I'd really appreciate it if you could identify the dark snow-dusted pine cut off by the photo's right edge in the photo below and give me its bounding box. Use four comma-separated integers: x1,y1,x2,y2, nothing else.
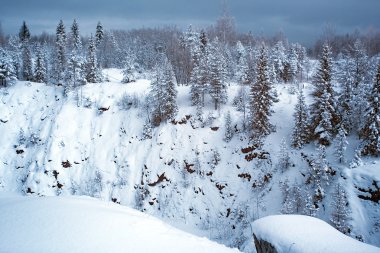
360,63,380,156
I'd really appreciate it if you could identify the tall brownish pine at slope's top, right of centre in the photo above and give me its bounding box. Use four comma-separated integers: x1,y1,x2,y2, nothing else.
249,45,274,143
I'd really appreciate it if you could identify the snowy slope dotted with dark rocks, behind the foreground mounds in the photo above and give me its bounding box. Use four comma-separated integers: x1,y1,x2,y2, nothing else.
0,69,380,252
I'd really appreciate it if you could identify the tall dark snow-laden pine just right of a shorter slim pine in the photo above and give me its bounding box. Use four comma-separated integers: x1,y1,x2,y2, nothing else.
310,44,339,145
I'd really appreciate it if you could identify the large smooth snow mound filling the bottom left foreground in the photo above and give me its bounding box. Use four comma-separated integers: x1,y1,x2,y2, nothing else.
0,194,238,253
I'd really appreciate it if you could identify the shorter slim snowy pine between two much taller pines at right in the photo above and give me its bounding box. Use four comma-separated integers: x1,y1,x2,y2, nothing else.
292,89,309,148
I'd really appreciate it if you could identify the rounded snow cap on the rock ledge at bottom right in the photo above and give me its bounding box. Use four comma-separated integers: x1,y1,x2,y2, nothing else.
252,215,380,253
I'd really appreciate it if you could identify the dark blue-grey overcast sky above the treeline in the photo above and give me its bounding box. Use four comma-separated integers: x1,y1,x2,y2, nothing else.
0,0,380,44
